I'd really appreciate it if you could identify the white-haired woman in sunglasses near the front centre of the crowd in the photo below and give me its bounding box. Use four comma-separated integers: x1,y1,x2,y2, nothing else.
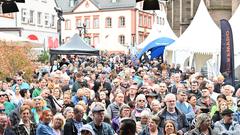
132,94,150,121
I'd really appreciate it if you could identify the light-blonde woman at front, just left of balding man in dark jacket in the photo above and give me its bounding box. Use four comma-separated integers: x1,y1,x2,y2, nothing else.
52,113,65,135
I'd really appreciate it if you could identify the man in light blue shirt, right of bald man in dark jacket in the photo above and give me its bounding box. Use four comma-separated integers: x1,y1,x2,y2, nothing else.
176,89,195,122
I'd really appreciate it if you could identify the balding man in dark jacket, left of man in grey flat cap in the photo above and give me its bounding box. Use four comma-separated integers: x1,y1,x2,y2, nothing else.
63,105,87,135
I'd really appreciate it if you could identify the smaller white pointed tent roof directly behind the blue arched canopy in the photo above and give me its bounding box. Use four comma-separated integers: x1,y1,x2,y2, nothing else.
137,10,177,49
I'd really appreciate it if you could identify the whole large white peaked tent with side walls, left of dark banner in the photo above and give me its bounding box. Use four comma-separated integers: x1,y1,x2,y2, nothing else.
165,0,221,74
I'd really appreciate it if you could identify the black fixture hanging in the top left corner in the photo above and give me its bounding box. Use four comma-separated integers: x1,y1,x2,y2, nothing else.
2,1,19,13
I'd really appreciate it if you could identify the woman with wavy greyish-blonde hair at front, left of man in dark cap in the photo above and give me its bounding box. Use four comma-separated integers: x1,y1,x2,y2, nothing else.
187,113,213,135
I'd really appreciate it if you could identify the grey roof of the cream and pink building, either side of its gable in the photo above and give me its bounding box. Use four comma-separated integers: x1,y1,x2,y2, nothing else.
56,0,136,12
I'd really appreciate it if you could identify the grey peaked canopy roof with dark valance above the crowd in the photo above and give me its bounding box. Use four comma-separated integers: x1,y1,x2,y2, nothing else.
50,34,99,55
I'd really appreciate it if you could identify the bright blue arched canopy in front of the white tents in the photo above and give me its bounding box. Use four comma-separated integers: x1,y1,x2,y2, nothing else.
138,37,175,59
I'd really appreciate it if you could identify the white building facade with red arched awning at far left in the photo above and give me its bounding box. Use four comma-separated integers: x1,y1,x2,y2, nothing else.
0,0,59,49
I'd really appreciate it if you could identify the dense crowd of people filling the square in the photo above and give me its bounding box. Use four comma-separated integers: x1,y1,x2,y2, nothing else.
0,55,240,135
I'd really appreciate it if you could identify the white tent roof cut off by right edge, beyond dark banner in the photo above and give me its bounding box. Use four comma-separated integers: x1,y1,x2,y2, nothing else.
229,5,240,53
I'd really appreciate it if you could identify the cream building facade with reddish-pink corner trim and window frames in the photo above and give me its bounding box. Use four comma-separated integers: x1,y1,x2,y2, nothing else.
57,0,164,46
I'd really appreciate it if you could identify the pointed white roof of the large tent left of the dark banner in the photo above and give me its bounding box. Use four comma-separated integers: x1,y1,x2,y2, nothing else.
166,0,221,54
